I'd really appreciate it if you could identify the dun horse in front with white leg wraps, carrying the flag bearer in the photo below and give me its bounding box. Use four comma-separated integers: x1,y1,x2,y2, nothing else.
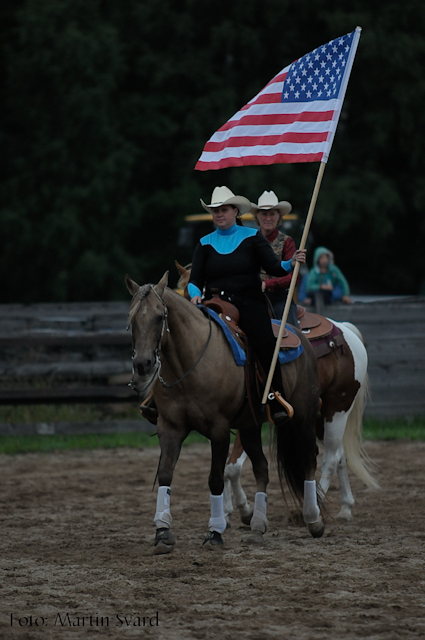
126,272,324,553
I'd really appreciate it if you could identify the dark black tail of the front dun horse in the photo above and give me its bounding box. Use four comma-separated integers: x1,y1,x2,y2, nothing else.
273,417,317,507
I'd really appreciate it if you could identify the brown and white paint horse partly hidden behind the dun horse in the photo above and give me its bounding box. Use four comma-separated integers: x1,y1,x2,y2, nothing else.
176,262,379,524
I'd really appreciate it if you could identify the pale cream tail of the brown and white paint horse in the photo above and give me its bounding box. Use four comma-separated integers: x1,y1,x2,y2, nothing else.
342,374,380,489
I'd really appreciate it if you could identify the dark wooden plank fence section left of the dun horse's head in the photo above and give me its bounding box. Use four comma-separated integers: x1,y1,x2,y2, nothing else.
0,302,132,404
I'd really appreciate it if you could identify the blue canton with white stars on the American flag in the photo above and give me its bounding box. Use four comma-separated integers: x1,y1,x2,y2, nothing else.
281,31,354,102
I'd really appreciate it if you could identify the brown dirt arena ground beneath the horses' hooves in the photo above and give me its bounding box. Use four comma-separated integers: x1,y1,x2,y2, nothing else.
0,442,425,640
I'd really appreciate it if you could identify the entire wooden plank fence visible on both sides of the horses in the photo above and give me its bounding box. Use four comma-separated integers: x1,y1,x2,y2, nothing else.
0,297,425,434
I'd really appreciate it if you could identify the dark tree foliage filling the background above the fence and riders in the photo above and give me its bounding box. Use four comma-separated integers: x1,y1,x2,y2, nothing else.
0,0,425,302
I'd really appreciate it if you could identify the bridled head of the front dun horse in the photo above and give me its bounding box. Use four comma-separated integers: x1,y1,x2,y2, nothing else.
125,271,168,396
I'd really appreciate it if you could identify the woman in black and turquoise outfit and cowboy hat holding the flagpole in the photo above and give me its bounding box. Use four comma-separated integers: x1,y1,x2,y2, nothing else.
188,187,305,426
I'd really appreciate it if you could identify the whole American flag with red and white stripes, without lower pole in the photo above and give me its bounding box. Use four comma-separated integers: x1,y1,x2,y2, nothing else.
195,27,361,171
